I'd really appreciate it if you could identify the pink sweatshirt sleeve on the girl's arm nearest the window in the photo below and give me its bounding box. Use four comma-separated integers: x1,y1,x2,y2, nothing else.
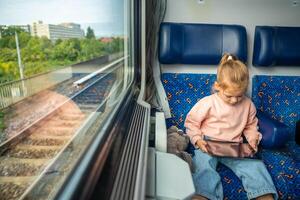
184,98,210,146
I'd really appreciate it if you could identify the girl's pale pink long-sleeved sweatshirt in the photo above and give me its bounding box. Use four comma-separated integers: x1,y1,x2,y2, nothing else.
184,93,262,150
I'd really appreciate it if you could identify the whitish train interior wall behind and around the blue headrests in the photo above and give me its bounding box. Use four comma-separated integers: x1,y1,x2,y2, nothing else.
162,0,300,96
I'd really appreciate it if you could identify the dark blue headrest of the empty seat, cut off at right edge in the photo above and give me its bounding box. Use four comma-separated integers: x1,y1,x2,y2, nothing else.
252,26,300,66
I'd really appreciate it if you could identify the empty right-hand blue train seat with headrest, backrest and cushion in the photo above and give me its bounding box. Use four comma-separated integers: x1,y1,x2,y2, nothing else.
252,26,300,199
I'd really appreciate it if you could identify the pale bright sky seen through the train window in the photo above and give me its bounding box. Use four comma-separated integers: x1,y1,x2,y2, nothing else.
0,0,124,36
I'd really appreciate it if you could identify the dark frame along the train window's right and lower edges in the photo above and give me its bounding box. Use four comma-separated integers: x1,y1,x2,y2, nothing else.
54,0,141,200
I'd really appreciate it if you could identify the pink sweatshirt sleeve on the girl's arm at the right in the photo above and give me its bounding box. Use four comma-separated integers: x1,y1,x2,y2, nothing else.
243,102,262,151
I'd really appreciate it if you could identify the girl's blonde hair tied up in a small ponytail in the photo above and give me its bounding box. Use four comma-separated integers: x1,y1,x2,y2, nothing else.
216,53,249,92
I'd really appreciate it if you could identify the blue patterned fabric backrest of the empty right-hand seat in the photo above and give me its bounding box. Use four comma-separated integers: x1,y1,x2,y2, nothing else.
252,76,300,131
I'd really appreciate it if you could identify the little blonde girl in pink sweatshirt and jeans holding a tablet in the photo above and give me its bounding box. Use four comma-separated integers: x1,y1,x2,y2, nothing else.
185,54,278,200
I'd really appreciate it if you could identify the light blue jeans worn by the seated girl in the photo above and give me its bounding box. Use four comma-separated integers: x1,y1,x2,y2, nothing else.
193,149,278,200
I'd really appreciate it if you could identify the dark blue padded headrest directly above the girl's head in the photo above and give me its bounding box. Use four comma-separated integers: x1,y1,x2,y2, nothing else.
159,23,247,65
